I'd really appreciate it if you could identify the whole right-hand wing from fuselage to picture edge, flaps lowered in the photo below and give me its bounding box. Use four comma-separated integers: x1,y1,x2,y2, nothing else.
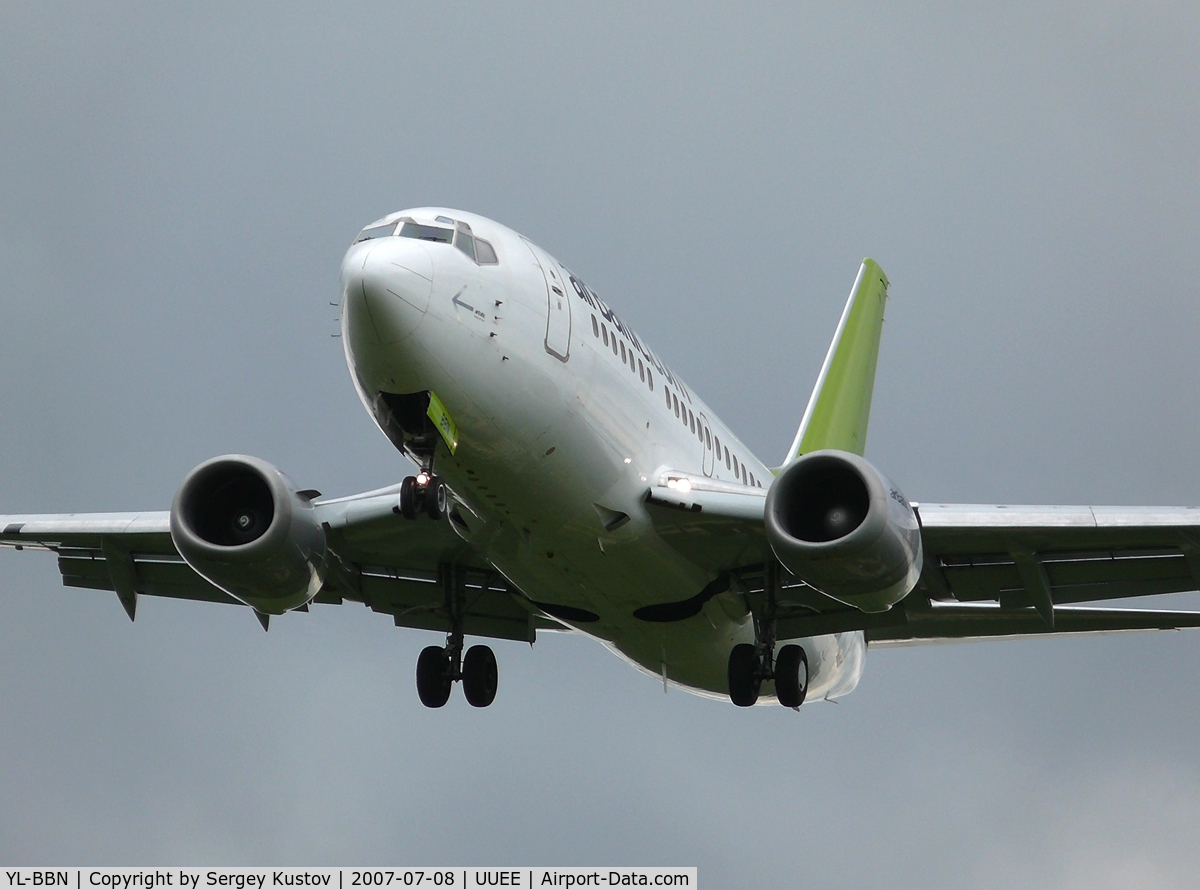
646,484,1200,645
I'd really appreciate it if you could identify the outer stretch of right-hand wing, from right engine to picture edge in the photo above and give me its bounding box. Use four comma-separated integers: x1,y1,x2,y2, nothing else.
883,504,1200,643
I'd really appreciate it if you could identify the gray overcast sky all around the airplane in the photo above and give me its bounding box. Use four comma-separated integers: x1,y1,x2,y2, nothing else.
0,2,1200,888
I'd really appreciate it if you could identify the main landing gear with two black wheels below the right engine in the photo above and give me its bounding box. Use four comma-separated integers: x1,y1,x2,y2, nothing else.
728,561,809,708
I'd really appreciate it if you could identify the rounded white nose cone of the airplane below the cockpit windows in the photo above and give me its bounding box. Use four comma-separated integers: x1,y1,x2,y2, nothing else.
342,237,433,345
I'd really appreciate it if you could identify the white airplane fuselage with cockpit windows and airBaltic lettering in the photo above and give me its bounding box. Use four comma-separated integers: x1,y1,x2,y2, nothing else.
341,208,865,700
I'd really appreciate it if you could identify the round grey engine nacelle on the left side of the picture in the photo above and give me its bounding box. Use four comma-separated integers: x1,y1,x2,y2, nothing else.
170,455,325,615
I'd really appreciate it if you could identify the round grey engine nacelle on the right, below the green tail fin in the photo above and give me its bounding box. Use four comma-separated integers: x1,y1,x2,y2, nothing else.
764,450,922,612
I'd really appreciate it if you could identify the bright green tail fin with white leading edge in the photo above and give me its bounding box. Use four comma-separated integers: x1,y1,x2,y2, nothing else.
784,258,888,464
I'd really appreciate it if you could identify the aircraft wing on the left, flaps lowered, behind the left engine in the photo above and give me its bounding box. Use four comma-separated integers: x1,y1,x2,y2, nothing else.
0,487,544,642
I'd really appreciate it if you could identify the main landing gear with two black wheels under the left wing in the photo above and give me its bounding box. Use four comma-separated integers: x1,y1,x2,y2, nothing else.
415,563,499,708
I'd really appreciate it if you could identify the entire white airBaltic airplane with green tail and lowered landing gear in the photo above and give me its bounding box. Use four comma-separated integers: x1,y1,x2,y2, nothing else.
0,208,1200,708
